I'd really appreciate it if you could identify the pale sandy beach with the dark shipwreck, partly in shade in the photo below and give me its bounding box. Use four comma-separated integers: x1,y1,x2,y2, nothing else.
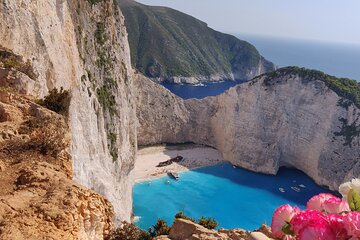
131,144,224,182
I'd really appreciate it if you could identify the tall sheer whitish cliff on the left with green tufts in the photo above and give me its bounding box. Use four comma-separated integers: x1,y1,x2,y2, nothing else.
0,0,137,220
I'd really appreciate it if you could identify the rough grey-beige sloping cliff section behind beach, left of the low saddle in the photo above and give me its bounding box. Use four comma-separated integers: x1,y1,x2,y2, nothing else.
135,74,191,145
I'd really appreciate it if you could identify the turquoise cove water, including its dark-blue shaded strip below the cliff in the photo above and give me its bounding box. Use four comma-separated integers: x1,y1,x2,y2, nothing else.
133,163,334,230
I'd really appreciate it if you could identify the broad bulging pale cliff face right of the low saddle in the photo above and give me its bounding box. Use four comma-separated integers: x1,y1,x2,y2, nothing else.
211,76,360,189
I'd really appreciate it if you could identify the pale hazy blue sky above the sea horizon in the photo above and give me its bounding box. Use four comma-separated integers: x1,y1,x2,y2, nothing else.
138,0,360,44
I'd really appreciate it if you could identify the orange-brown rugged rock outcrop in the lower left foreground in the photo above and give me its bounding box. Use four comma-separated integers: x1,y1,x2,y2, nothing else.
0,91,113,240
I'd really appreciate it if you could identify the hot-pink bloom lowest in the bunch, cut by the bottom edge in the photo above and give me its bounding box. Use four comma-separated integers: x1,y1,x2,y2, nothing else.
297,222,338,240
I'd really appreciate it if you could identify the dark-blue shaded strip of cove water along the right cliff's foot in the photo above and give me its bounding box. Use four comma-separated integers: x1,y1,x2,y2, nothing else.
192,163,336,206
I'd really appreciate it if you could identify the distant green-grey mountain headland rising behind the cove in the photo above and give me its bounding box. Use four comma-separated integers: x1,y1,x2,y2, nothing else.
118,0,274,83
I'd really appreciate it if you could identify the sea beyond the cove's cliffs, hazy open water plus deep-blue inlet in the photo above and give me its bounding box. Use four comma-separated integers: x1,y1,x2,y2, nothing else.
164,34,360,99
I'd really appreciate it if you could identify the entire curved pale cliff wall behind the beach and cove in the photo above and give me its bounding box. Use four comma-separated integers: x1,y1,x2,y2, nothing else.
137,68,360,189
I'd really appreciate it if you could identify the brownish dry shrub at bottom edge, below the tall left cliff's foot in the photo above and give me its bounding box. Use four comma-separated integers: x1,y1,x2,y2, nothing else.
105,222,152,240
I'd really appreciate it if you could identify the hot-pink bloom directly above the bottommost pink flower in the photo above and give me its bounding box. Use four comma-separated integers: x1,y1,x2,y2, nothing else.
290,210,328,235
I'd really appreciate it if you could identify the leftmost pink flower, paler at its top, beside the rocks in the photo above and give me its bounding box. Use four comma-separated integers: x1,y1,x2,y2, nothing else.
271,204,300,238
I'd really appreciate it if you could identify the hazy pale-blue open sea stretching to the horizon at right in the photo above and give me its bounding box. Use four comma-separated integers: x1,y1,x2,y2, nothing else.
236,34,360,81
